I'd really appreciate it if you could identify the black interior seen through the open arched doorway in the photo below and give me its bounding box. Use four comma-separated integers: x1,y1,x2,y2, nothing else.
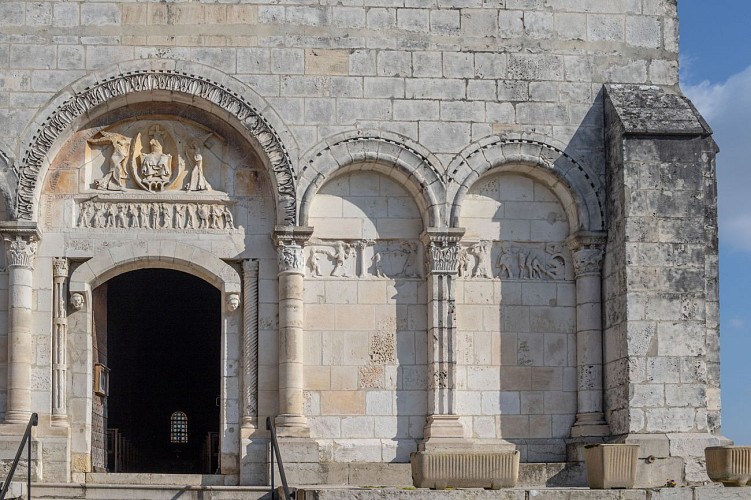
107,269,221,473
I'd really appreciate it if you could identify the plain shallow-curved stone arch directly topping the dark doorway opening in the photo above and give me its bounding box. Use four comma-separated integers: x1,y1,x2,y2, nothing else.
69,241,242,294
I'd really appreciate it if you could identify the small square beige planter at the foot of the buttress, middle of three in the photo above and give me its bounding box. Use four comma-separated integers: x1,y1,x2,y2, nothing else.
584,444,639,489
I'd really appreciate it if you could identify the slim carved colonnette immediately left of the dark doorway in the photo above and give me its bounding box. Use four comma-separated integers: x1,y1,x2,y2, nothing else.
51,257,68,426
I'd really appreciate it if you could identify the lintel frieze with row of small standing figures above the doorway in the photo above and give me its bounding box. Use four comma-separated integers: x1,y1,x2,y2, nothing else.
77,200,235,231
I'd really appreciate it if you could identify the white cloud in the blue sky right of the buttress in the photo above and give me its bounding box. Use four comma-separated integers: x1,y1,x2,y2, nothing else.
683,66,751,252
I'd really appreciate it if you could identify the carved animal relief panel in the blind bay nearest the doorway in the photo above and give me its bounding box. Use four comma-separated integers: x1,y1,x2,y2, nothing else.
305,240,424,278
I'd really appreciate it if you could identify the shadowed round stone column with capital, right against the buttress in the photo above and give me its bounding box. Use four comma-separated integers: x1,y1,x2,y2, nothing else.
567,233,610,437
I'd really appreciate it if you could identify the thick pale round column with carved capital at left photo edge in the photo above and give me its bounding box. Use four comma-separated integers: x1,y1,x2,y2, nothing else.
0,223,39,424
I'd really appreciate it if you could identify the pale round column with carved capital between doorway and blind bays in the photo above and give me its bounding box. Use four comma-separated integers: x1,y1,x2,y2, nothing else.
274,226,313,437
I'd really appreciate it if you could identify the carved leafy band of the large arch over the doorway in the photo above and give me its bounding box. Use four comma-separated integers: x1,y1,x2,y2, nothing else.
16,64,296,225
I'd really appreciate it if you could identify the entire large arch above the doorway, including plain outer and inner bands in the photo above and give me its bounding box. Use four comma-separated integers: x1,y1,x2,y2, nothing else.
14,60,297,225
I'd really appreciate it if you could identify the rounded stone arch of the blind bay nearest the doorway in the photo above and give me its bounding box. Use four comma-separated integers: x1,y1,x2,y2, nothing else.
297,131,446,227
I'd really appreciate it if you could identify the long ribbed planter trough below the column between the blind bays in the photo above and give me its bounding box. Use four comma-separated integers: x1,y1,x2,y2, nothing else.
410,451,519,489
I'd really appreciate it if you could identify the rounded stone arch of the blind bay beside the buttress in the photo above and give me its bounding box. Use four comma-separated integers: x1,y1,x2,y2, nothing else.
448,136,605,233
